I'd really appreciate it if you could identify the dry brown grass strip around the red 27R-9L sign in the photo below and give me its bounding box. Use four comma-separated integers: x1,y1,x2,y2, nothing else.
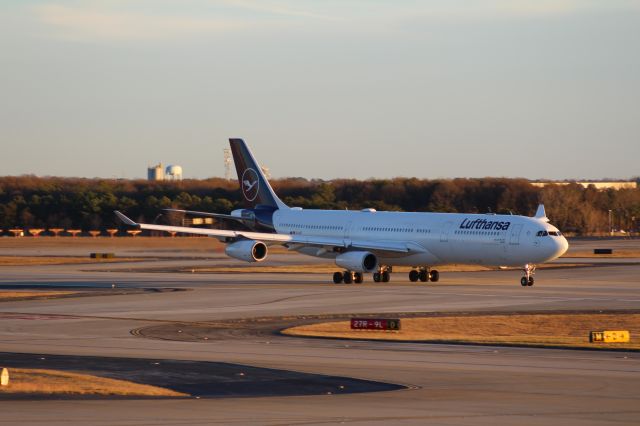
283,314,640,349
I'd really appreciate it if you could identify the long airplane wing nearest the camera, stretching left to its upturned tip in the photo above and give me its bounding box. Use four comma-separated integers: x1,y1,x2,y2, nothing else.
115,211,426,255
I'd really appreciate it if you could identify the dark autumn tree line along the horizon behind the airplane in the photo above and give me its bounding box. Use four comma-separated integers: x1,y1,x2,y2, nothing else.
0,176,640,235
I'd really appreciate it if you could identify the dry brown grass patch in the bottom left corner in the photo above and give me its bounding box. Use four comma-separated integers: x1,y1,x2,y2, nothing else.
0,368,188,396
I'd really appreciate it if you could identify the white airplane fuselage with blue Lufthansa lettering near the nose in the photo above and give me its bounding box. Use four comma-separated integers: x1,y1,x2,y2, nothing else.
273,208,568,266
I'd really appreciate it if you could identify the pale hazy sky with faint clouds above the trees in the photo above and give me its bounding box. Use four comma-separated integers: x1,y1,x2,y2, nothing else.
0,0,640,179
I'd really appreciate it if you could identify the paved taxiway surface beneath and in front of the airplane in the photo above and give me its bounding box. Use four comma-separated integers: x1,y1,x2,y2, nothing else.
0,238,640,425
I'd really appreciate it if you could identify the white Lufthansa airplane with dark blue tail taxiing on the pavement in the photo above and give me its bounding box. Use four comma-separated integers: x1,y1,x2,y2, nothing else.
115,139,569,287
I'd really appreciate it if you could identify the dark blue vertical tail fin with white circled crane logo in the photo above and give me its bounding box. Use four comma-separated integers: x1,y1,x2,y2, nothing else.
229,139,287,210
